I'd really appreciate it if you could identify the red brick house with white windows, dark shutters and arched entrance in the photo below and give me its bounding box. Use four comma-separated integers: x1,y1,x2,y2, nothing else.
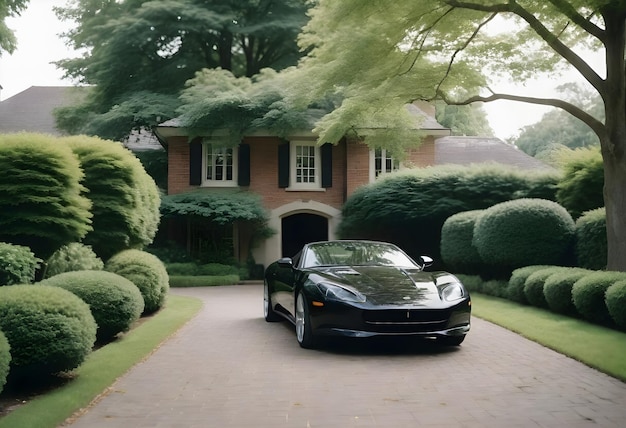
154,101,450,266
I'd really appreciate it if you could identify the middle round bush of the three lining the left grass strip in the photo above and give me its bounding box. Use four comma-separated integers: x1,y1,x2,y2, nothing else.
39,270,144,340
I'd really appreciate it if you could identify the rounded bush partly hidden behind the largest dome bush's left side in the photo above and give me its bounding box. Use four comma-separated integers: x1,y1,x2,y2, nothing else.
440,210,483,274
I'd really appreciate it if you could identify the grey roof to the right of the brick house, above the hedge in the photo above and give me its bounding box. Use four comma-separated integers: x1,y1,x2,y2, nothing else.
435,136,553,171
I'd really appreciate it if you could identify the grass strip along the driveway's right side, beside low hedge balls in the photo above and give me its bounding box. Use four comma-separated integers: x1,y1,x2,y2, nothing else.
472,293,626,381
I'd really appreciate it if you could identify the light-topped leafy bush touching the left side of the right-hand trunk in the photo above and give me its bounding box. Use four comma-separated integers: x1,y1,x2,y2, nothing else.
556,146,604,218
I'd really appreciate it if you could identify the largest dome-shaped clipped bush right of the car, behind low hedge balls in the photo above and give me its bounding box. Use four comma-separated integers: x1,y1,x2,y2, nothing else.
473,199,574,272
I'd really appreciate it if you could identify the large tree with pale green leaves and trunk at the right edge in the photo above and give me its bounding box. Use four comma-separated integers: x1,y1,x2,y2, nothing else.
290,0,626,271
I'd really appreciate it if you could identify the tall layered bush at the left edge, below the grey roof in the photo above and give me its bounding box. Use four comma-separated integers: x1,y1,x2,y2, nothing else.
0,133,91,260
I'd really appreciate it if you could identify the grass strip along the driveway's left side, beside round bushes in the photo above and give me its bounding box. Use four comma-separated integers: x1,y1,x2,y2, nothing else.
0,294,202,428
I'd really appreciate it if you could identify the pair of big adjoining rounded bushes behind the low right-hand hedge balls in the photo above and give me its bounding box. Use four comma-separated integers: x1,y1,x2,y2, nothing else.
441,198,575,279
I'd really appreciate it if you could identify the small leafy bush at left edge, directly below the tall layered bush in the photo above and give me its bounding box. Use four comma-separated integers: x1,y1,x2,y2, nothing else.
0,242,41,285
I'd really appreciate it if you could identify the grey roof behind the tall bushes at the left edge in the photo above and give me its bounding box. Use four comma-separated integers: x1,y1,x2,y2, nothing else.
0,86,85,135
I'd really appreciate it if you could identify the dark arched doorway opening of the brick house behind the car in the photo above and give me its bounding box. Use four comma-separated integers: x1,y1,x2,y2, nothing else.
281,213,328,257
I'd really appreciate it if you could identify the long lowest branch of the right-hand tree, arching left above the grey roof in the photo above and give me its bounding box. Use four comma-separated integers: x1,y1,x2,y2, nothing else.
438,92,606,139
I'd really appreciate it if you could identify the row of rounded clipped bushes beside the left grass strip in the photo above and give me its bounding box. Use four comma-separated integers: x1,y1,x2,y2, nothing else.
0,246,169,387
